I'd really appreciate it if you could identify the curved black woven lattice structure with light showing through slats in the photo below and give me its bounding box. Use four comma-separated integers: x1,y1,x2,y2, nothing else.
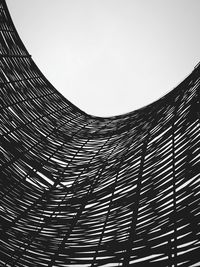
0,0,200,267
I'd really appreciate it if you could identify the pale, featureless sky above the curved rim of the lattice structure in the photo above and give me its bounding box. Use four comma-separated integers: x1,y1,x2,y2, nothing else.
7,0,200,116
